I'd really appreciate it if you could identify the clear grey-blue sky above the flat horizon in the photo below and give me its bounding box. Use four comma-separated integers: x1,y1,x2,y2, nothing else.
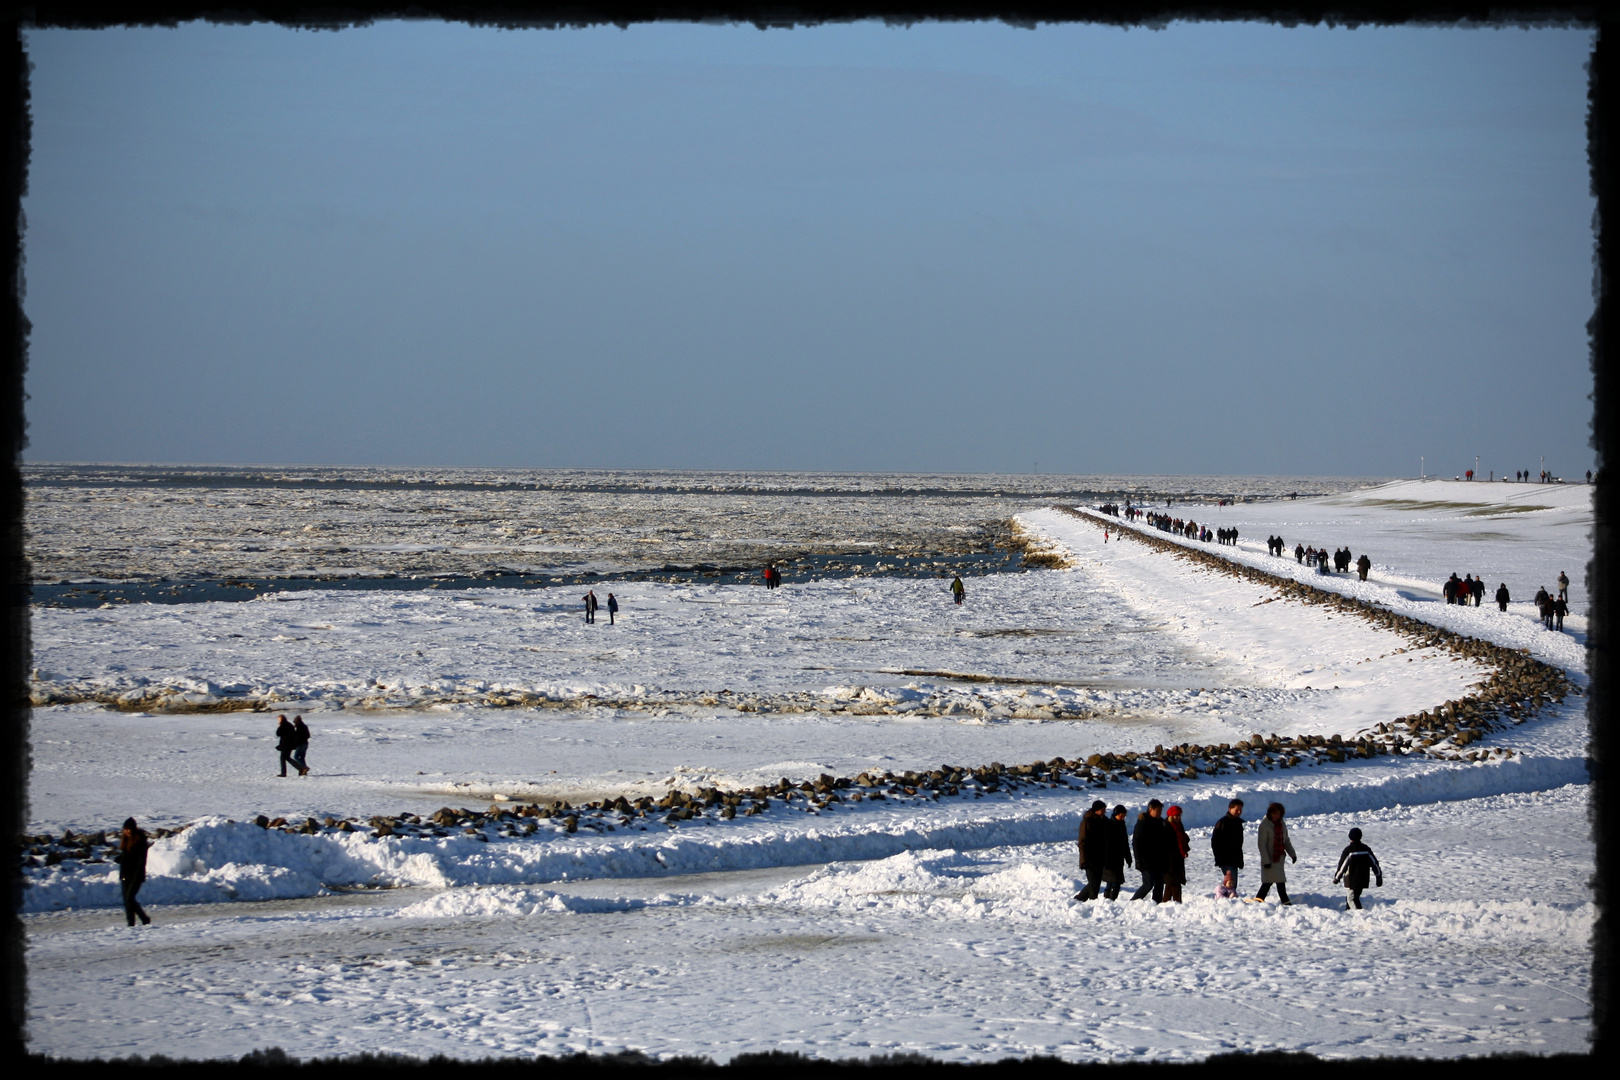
24,23,1596,476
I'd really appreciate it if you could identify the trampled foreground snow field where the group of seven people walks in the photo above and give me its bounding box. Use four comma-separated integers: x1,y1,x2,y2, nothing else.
29,785,1592,1061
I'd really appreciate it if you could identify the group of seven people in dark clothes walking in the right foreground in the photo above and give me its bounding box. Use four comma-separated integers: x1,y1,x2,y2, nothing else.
1074,798,1383,910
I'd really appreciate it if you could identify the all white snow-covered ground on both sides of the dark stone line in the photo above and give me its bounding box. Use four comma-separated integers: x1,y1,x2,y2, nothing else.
24,484,1592,1061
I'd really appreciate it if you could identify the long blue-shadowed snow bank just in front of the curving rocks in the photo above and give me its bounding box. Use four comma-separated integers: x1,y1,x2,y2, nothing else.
24,706,1586,912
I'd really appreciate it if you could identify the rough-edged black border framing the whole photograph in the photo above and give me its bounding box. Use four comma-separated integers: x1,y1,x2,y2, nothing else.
0,0,1620,1075
